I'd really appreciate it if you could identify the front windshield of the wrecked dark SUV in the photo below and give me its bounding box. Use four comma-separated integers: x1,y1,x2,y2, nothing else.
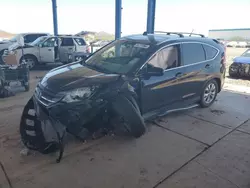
85,40,150,74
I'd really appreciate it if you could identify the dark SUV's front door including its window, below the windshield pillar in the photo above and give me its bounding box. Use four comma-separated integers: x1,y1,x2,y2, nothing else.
141,45,185,113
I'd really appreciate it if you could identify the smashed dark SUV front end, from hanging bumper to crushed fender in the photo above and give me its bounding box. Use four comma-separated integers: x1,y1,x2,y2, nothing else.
20,78,145,162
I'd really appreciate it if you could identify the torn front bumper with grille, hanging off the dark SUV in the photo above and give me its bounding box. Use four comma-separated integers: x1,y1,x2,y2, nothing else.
20,84,106,162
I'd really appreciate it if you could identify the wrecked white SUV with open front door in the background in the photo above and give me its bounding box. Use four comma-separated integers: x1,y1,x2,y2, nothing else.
3,35,90,69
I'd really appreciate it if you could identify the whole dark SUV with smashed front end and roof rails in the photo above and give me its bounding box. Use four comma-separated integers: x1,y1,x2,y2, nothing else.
20,32,225,162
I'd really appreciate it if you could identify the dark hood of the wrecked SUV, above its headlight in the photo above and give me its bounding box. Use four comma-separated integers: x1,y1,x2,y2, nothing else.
41,62,119,93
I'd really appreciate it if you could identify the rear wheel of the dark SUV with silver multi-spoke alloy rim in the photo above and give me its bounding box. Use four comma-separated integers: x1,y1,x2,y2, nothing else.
200,79,218,108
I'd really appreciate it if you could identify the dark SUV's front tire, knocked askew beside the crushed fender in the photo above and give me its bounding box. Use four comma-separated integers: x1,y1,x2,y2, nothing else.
112,95,146,138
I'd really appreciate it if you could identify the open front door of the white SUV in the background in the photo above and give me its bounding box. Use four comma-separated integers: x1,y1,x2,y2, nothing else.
39,37,56,63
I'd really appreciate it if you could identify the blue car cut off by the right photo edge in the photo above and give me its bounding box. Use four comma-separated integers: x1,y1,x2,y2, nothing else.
229,49,250,77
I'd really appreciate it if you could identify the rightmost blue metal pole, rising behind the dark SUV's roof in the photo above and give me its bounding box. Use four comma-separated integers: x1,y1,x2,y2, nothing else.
147,0,156,33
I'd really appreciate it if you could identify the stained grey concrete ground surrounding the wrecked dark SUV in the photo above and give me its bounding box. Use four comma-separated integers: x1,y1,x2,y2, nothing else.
0,48,250,188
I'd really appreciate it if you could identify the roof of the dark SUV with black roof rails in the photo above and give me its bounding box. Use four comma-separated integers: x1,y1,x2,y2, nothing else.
121,34,219,45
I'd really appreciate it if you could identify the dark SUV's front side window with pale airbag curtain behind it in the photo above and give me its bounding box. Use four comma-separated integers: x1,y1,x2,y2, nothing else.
148,45,180,70
